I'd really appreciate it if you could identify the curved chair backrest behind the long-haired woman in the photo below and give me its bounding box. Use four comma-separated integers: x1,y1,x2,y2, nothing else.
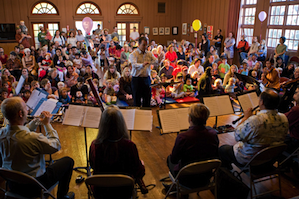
85,174,135,188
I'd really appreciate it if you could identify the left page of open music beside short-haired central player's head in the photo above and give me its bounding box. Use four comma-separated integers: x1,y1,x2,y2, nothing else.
159,109,181,133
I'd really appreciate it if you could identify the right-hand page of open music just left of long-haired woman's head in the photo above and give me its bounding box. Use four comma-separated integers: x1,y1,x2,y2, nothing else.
82,107,102,129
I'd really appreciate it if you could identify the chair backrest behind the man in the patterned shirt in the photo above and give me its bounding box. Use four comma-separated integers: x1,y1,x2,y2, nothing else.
247,144,287,166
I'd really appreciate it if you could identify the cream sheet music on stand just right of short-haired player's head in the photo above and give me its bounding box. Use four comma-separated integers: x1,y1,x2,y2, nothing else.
203,95,234,117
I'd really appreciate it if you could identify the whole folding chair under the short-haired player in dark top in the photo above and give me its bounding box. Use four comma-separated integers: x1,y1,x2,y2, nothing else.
165,159,221,199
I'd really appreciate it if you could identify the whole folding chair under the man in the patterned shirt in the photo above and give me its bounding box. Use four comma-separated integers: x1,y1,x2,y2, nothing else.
234,144,286,198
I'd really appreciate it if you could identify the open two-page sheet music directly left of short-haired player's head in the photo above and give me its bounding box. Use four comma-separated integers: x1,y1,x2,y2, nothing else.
157,108,189,133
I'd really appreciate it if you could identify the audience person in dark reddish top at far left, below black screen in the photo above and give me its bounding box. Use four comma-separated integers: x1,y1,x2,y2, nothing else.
6,51,23,81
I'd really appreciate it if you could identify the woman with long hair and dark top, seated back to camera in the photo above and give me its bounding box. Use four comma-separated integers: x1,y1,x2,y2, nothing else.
89,106,148,198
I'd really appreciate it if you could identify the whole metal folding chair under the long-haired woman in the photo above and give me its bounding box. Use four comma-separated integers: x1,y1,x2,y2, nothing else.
85,174,136,199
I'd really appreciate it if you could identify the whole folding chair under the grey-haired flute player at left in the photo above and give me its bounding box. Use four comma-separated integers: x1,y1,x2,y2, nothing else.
0,168,58,199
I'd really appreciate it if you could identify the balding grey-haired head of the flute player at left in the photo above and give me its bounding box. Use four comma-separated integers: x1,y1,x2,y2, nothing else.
1,97,27,124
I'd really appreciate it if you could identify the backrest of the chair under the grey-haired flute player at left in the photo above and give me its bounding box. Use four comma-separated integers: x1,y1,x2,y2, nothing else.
0,168,43,188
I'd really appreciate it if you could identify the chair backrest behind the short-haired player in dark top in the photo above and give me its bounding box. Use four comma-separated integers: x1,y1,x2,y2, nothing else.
177,159,221,178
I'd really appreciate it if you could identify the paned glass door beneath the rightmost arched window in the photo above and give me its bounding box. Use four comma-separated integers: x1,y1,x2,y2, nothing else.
117,22,140,46
